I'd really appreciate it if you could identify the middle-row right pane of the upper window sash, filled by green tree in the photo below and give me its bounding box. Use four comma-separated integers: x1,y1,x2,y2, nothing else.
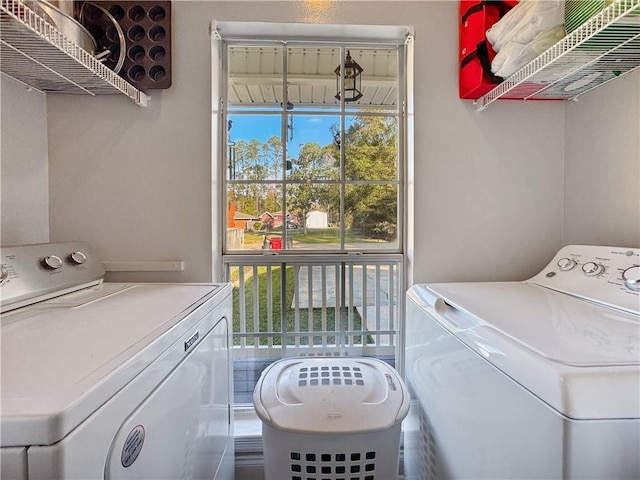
345,115,398,181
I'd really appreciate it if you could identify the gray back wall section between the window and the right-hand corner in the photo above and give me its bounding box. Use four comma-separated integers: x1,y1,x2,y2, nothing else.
406,2,564,282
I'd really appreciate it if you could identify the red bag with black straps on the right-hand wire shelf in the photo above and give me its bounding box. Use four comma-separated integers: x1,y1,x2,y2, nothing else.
459,0,518,99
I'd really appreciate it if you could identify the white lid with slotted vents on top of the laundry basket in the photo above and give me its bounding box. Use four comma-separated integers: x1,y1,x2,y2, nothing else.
253,357,409,434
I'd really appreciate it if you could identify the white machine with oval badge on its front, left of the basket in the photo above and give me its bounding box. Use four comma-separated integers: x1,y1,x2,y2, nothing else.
0,242,234,480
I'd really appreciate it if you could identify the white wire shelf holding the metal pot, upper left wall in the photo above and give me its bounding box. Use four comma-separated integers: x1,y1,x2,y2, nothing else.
0,0,149,106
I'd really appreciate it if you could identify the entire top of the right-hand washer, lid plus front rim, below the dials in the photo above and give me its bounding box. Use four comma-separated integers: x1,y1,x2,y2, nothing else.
411,282,640,418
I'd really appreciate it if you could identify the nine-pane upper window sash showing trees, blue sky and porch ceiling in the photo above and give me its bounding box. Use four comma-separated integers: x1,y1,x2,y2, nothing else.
225,45,402,252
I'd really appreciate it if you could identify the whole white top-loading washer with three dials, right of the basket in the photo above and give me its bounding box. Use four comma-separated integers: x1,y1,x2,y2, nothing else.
405,246,640,480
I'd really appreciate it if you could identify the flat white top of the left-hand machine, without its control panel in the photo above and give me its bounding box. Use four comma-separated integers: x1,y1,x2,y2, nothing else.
0,284,222,447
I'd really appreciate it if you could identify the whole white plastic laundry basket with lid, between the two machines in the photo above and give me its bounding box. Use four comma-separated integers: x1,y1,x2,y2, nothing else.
253,357,409,480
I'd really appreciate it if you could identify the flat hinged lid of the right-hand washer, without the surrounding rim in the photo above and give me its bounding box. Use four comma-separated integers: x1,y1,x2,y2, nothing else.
429,282,640,367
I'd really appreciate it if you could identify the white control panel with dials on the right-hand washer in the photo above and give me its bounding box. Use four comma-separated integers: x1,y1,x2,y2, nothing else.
526,245,640,315
